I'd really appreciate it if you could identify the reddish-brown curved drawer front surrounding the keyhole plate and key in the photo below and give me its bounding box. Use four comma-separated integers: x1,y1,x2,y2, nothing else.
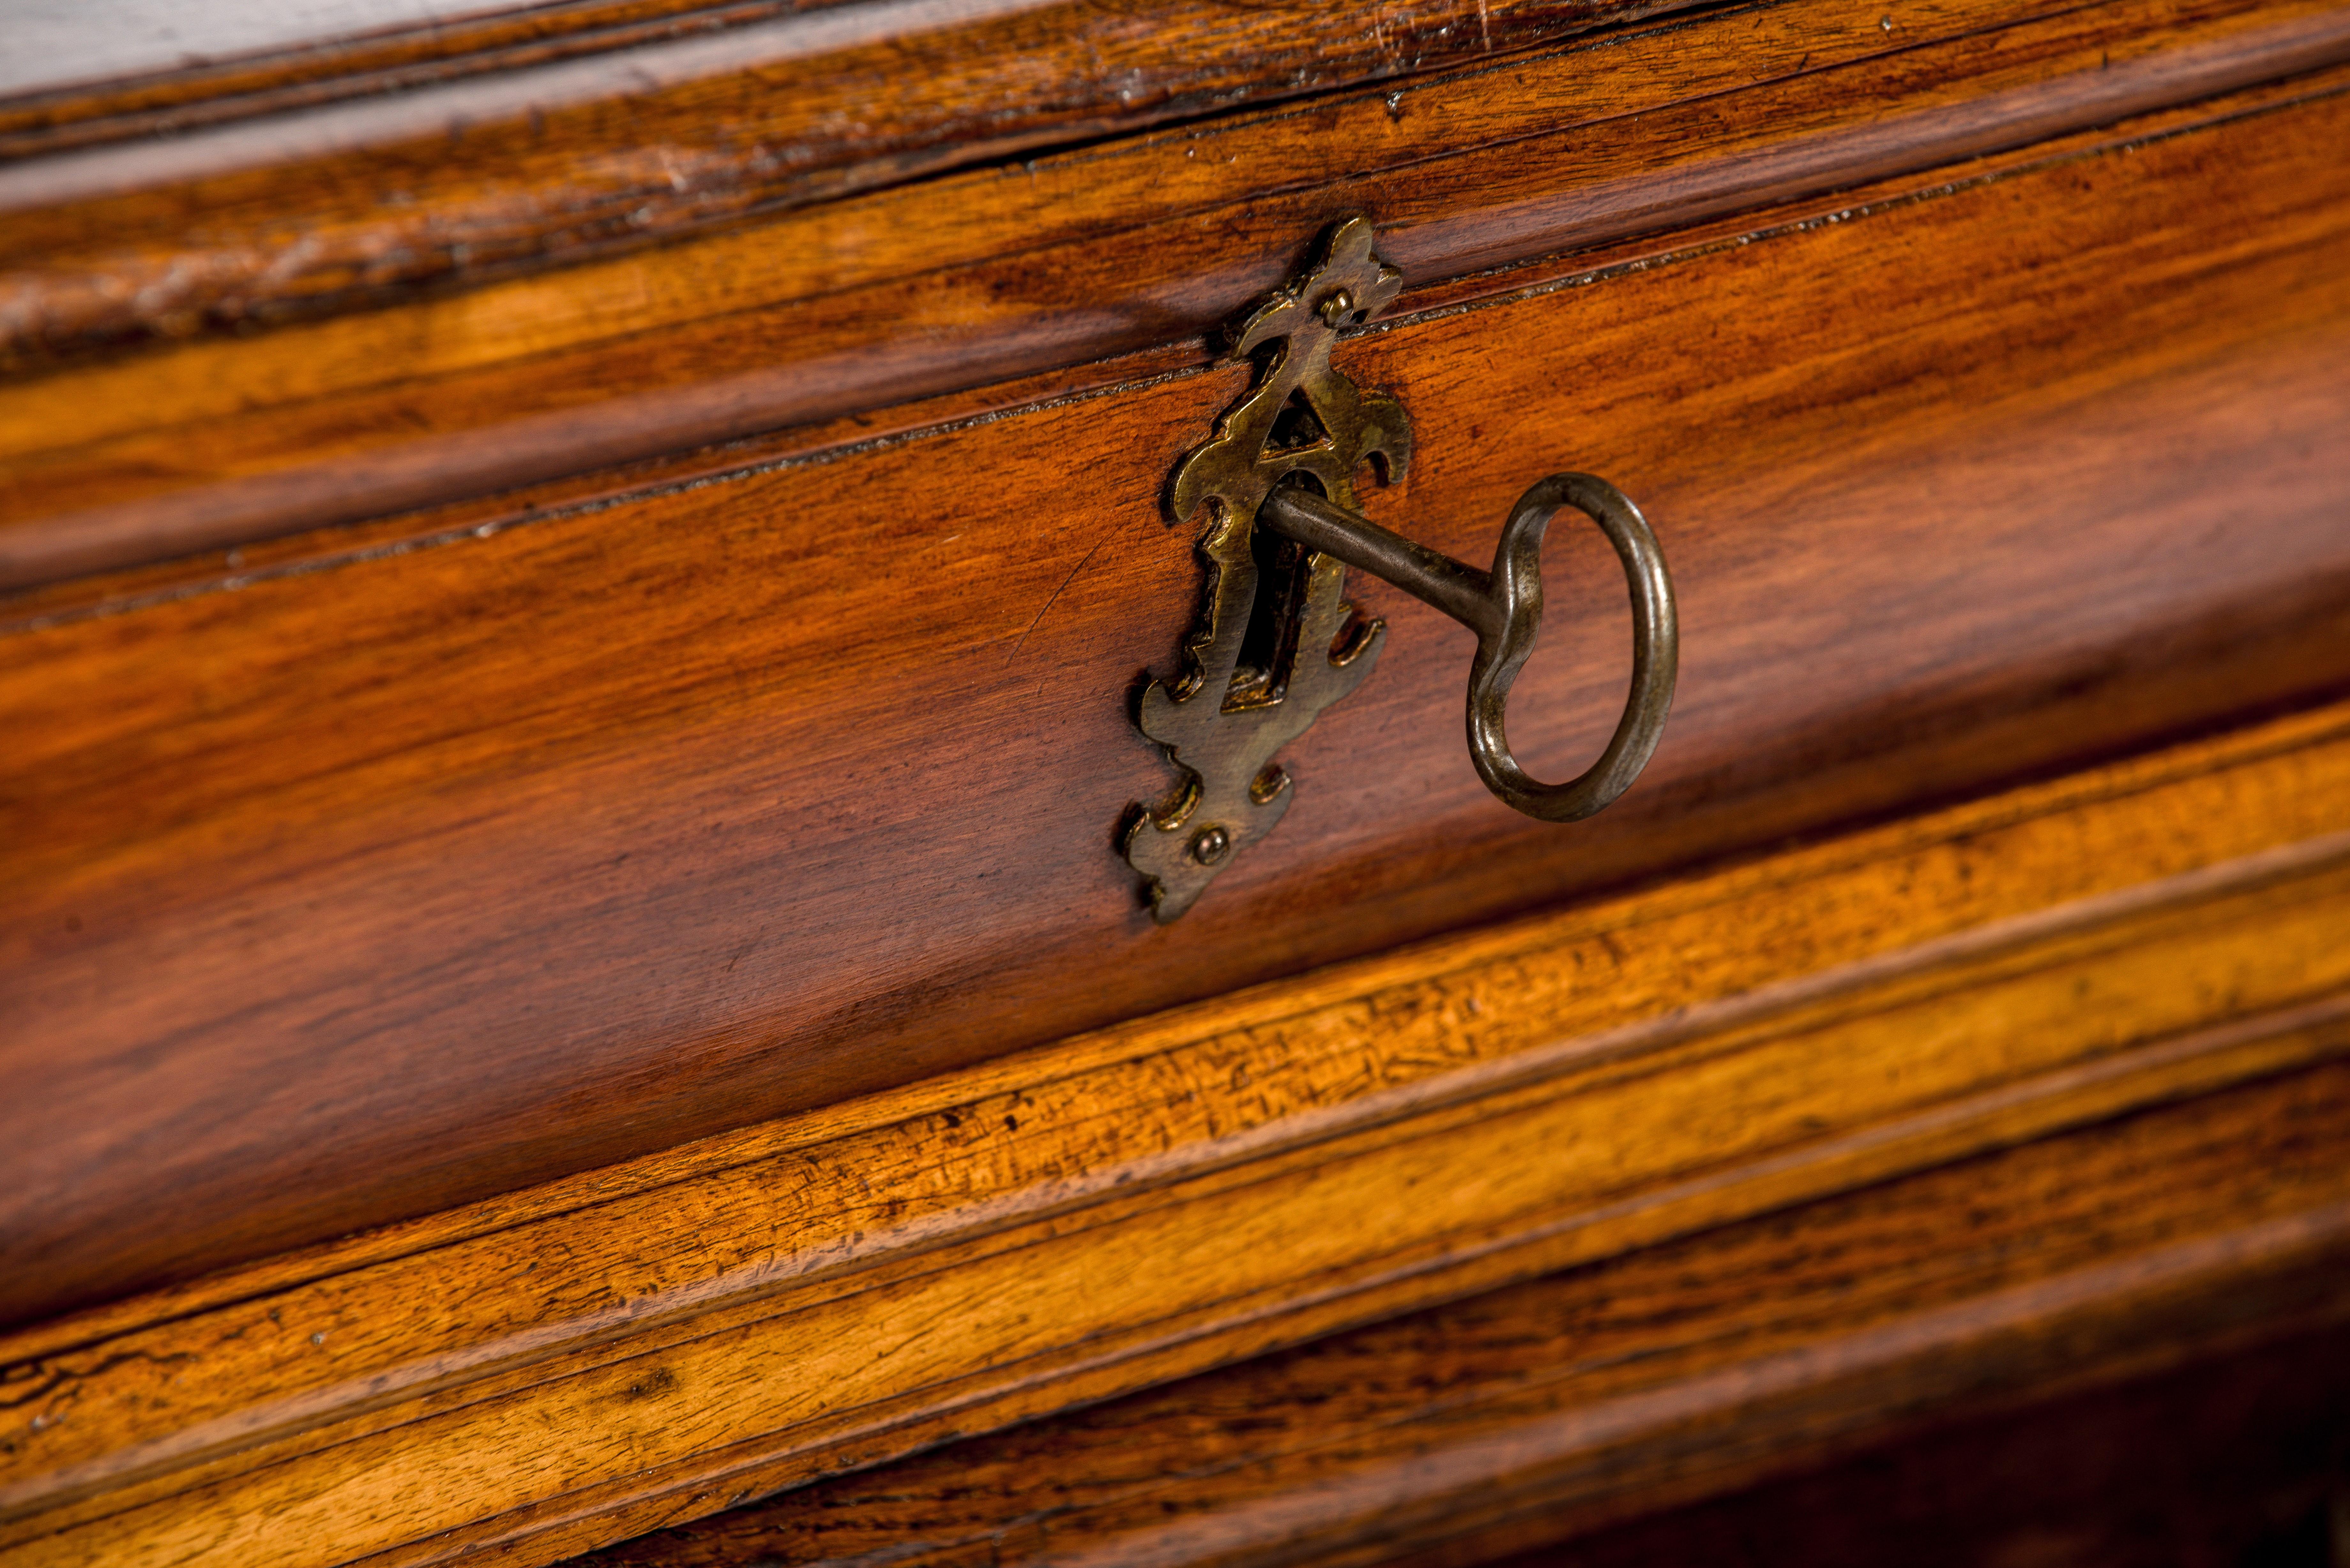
14,80,2350,1319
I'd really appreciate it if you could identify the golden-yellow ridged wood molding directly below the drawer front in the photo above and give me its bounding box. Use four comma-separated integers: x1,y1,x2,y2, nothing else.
14,708,2350,1568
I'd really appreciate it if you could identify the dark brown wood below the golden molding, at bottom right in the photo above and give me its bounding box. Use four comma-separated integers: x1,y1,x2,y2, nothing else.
559,1065,2350,1568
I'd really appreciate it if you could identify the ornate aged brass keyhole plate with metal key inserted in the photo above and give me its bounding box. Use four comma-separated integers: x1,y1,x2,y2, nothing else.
1126,216,1678,924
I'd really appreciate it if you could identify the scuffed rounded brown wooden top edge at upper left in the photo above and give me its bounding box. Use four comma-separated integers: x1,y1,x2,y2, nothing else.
0,0,1701,355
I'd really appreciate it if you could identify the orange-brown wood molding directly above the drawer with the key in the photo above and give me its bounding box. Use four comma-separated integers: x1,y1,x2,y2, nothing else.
0,0,2350,585
